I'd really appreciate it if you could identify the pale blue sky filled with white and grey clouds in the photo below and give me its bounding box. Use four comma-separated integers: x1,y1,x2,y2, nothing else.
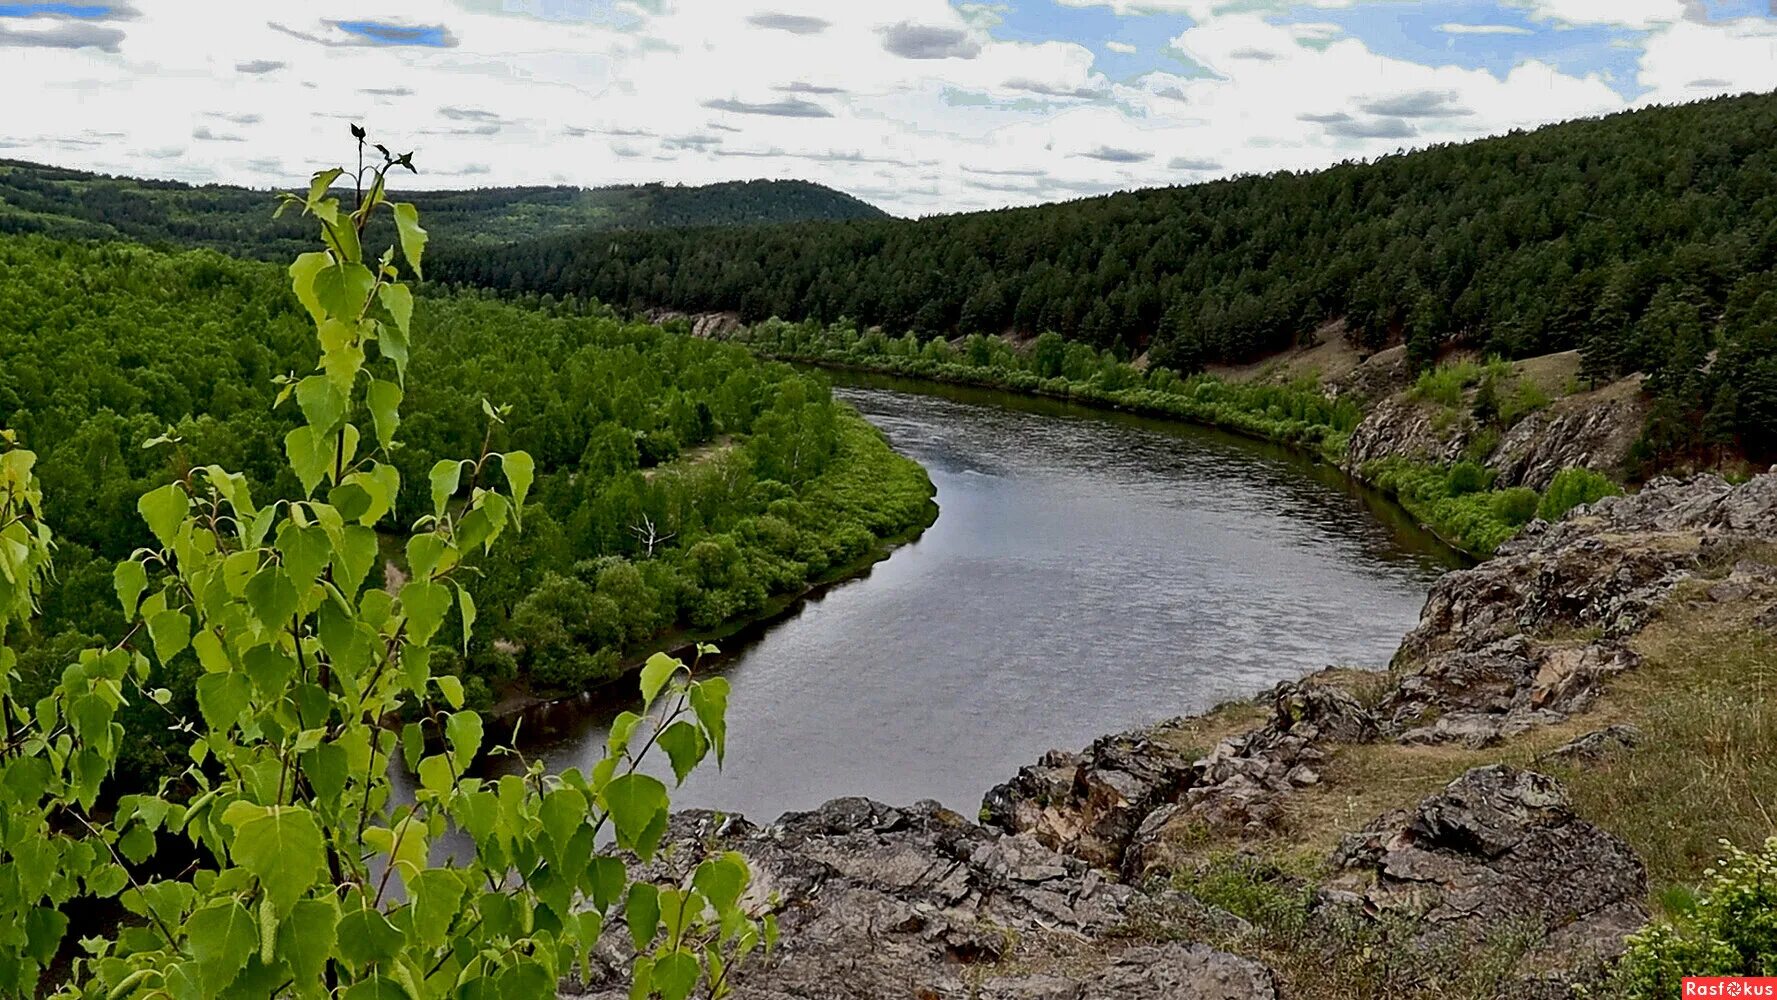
0,0,1777,217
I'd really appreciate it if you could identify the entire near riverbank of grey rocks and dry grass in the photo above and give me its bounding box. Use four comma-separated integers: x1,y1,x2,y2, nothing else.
575,474,1777,1000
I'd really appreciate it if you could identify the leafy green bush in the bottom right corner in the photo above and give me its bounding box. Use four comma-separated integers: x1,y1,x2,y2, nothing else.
1601,837,1777,1000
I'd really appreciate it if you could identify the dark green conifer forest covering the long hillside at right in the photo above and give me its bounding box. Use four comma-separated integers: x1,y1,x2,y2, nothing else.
435,94,1777,458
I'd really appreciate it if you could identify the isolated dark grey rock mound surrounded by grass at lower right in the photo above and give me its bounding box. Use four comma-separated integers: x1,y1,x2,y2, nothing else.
1333,766,1647,964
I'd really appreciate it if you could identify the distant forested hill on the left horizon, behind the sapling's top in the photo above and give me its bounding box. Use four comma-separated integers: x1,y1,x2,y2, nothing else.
0,160,887,259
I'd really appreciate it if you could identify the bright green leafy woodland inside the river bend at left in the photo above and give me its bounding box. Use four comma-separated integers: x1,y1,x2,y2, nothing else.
0,227,933,781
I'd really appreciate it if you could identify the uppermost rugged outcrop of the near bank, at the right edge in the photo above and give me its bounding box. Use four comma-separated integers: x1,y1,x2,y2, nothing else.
1379,476,1777,746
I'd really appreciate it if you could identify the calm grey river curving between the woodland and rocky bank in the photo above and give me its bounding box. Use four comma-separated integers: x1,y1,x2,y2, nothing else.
490,373,1459,821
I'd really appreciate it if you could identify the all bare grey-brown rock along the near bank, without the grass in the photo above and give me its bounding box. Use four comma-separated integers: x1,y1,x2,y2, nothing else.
570,474,1777,1000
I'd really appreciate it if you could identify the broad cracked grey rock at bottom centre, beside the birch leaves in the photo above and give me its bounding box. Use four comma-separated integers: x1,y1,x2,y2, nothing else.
567,799,1276,1000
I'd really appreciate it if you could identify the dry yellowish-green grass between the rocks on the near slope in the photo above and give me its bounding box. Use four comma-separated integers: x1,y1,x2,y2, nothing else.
1108,561,1777,1000
